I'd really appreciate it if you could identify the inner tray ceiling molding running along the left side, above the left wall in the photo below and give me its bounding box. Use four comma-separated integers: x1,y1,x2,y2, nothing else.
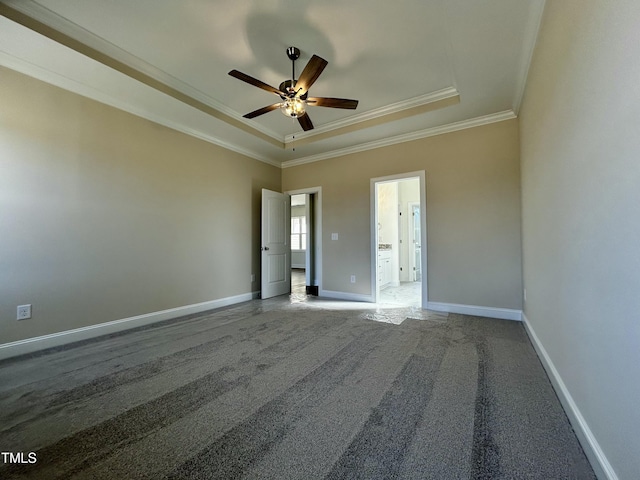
0,0,284,148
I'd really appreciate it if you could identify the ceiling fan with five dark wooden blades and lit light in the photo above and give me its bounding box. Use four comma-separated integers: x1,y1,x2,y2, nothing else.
229,47,358,131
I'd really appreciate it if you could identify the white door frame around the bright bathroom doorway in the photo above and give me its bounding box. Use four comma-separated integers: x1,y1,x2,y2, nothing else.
369,170,429,309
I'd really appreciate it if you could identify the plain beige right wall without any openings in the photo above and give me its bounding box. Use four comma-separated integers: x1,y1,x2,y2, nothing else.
520,0,640,479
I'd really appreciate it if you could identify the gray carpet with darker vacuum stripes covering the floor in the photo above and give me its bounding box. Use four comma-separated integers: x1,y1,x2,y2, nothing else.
0,297,595,480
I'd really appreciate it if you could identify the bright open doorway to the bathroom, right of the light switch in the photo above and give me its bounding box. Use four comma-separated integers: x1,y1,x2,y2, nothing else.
371,172,428,308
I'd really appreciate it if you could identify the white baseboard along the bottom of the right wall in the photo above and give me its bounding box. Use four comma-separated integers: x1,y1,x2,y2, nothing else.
522,312,618,480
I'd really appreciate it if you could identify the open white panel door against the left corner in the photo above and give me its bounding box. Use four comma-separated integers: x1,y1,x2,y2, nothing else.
260,188,291,298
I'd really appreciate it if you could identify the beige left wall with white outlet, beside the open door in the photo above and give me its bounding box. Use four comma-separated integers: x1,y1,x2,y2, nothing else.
0,68,280,343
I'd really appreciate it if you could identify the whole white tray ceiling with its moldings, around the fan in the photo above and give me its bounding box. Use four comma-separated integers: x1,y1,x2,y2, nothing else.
0,0,544,166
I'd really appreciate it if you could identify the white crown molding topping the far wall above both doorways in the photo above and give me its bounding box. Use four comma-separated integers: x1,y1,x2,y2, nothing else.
281,110,517,168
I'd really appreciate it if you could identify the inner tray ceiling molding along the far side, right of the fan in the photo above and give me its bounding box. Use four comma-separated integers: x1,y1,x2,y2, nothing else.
284,87,459,145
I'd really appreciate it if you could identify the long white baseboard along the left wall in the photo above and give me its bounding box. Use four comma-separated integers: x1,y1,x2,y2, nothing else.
0,292,260,360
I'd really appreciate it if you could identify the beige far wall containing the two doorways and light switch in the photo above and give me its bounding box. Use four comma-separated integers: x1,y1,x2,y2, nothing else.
282,120,522,309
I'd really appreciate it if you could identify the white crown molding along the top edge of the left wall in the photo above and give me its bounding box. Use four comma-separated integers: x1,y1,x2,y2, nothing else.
0,51,280,167
